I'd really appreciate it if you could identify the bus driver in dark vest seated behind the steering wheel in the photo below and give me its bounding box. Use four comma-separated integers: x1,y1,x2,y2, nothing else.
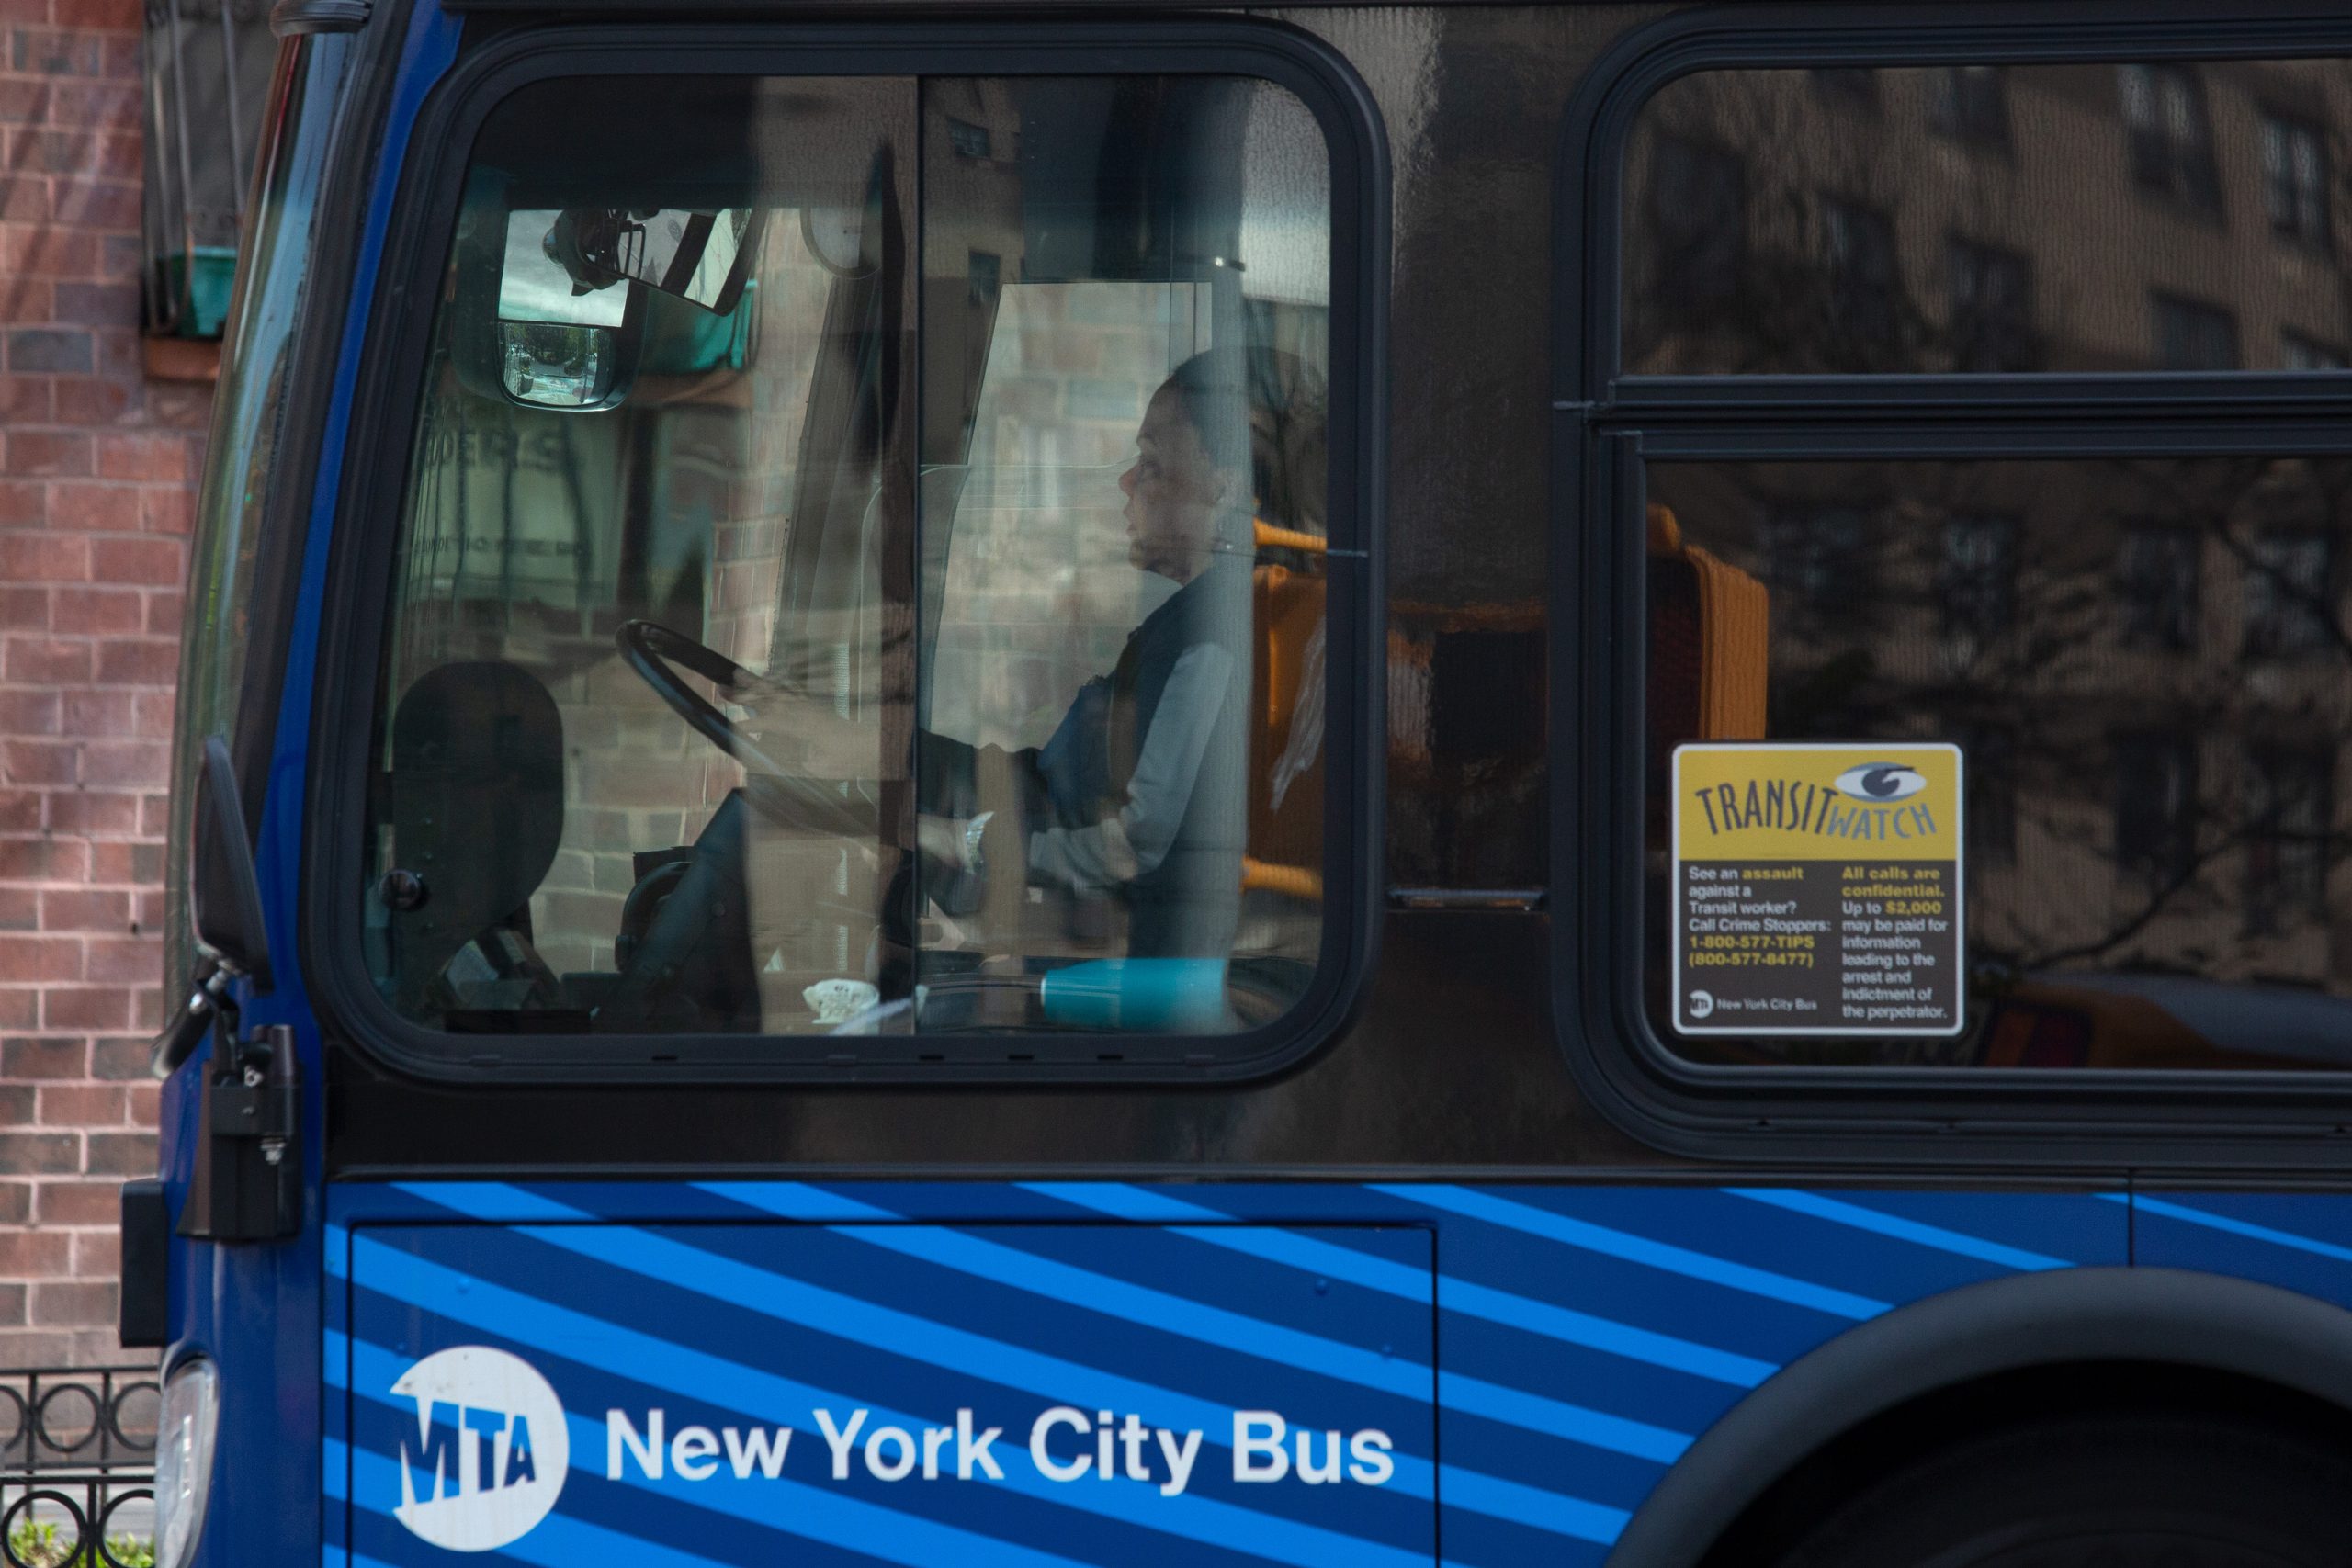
915,353,1322,957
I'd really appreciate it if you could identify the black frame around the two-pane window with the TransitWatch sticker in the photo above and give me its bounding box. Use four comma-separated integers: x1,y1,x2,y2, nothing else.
1553,0,2352,1168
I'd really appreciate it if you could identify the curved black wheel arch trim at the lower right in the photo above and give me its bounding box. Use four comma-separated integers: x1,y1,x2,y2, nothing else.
1606,1267,2352,1568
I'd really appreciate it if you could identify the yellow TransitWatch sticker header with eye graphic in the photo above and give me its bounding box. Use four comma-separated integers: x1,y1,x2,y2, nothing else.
1675,740,1962,863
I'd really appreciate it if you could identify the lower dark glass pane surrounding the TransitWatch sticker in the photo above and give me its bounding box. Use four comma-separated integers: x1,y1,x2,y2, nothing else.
1646,458,2352,1069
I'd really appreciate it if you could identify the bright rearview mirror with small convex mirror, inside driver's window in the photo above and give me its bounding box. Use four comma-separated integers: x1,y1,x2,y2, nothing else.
496,209,644,412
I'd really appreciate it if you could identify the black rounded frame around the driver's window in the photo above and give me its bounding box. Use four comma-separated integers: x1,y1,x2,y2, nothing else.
301,21,1390,1086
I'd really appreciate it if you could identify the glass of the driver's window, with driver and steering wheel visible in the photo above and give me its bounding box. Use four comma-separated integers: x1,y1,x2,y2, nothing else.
365,77,1331,1034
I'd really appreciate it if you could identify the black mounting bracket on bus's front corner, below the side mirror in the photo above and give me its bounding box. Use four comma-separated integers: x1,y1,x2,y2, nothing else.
179,1025,301,1241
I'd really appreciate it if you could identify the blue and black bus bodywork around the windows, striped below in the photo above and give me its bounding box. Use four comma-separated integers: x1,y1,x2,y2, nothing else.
147,0,2352,1568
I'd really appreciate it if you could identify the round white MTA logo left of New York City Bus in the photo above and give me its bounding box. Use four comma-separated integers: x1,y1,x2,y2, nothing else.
393,1345,571,1551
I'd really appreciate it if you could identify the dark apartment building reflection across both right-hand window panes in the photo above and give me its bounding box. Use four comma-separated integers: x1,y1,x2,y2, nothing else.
1621,59,2352,1069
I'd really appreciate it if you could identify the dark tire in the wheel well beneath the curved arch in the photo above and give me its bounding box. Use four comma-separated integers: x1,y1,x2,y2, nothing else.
1778,1413,2352,1568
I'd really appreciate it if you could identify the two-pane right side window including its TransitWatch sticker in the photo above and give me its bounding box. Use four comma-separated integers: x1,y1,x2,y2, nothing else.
1578,49,2352,1072
